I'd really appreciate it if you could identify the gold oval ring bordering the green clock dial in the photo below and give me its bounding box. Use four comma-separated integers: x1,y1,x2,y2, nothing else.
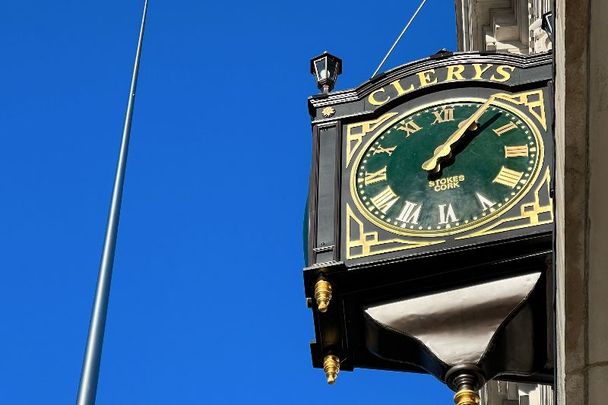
349,97,545,238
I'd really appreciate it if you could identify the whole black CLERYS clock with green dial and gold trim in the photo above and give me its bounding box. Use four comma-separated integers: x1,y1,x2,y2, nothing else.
304,52,554,388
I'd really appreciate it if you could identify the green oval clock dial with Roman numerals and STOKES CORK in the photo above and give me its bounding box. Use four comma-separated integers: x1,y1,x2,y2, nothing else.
351,100,543,236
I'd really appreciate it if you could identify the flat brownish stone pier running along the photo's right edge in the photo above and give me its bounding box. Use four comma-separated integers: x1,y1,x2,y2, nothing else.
555,0,608,405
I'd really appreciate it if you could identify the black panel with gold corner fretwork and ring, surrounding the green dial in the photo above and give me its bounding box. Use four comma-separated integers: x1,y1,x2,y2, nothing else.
340,86,553,263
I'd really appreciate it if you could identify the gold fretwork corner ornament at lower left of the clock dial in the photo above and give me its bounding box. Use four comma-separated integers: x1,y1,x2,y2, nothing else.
346,204,445,259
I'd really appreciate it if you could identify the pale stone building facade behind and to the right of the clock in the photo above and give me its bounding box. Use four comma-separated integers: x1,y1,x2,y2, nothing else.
455,0,608,405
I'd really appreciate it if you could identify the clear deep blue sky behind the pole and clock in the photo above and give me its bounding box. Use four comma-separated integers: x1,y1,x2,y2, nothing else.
0,0,456,405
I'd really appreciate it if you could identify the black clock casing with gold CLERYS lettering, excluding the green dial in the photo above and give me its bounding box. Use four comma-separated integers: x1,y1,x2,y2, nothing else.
303,52,554,382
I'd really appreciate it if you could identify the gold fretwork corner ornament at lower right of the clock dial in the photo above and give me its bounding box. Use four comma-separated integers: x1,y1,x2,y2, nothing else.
456,168,553,239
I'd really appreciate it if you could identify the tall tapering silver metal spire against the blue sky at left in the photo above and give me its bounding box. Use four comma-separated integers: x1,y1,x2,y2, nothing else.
76,0,148,405
